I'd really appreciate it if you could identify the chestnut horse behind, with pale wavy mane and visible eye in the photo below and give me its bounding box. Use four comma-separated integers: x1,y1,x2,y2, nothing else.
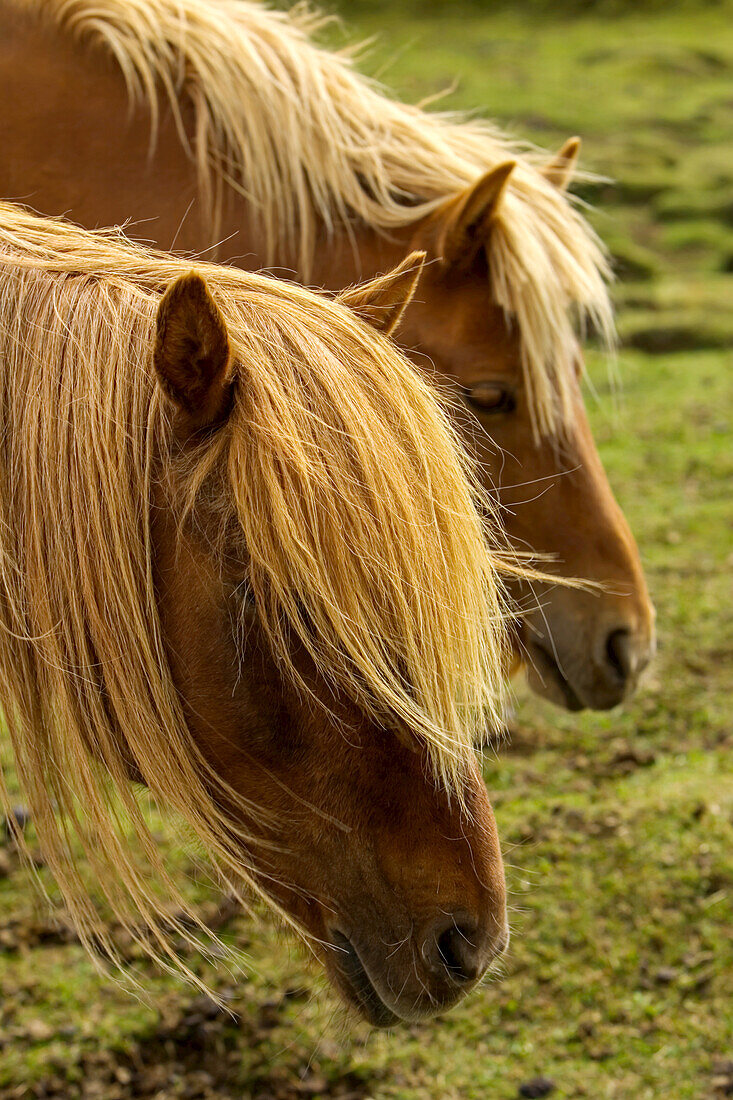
0,0,654,710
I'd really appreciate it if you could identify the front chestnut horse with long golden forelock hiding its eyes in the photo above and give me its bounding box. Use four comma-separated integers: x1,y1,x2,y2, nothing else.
0,202,512,1026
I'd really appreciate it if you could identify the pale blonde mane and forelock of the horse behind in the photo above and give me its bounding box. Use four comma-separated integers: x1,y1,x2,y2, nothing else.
12,0,613,435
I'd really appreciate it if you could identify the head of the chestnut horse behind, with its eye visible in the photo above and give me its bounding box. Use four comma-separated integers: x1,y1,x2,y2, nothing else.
387,146,654,710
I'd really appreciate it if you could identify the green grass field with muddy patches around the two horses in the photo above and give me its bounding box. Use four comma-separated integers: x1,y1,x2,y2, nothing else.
0,0,733,1100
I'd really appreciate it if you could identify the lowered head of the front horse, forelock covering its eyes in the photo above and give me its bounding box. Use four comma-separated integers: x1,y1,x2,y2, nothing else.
147,257,507,1025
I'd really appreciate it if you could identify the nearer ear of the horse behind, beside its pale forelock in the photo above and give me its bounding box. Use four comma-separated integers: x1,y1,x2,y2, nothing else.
435,161,516,267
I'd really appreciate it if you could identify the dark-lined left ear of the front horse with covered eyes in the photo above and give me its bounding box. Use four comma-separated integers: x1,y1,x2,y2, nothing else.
153,271,231,432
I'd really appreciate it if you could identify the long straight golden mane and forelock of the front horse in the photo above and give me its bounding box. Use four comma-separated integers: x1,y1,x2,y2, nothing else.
0,204,502,981
